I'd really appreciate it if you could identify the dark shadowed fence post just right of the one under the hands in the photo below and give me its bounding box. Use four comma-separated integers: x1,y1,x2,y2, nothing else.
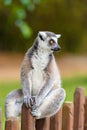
36,118,50,130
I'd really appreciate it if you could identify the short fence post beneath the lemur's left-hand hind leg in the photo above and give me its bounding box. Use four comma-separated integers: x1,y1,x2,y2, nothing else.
5,118,19,130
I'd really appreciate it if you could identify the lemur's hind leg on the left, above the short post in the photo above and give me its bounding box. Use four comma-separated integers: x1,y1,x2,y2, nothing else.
5,89,23,118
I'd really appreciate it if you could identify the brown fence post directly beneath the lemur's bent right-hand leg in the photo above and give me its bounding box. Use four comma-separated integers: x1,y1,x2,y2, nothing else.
50,108,62,130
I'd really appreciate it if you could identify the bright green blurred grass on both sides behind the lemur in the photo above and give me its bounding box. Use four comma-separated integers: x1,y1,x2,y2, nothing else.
0,76,87,127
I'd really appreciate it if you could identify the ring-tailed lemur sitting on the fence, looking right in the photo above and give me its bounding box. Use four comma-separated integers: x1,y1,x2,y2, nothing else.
5,31,66,119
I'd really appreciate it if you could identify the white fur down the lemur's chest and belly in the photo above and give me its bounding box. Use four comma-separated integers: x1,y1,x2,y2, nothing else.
31,48,49,95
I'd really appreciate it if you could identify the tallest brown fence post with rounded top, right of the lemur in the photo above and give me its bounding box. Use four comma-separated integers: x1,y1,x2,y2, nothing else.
74,88,85,130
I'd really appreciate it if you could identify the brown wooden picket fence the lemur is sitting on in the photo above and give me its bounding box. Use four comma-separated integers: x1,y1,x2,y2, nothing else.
0,88,87,130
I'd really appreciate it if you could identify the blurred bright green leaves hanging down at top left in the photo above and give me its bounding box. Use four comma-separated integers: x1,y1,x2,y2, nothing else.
3,0,39,38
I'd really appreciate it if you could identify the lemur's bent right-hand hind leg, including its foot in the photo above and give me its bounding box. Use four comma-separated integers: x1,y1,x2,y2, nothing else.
32,88,66,119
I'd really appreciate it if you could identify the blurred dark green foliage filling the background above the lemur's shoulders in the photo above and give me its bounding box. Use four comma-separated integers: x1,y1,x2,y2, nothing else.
0,0,87,53
